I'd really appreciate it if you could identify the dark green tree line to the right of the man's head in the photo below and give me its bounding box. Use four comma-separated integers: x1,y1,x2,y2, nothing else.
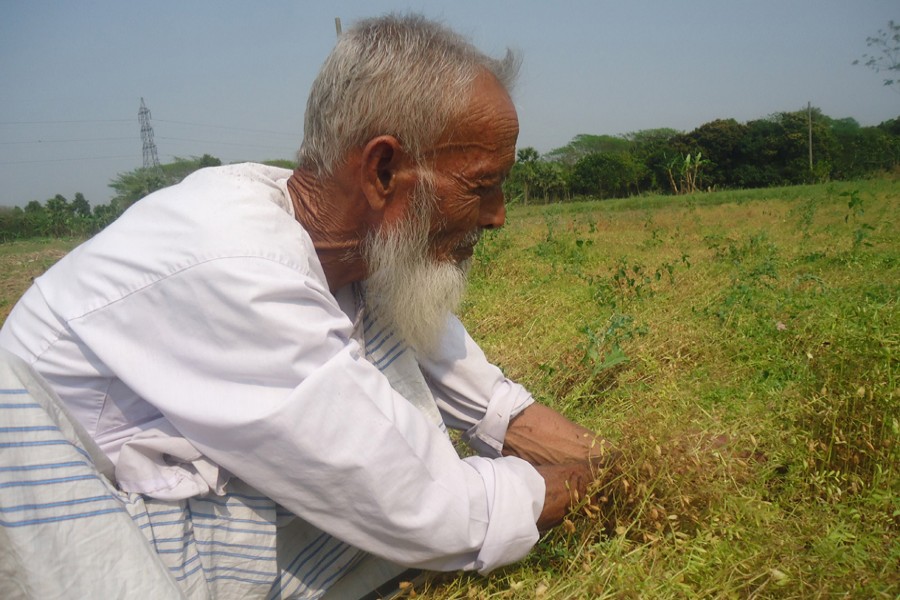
505,107,900,204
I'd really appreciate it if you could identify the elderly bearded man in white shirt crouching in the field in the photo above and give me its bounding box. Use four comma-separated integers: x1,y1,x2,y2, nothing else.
0,16,604,598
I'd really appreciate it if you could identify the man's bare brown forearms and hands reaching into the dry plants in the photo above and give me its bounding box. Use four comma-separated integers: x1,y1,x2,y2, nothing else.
503,404,619,531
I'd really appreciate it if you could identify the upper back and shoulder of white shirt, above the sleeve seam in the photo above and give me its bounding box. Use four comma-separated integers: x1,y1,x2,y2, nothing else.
31,159,324,317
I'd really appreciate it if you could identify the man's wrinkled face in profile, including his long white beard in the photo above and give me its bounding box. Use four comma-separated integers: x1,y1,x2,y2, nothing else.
364,75,519,353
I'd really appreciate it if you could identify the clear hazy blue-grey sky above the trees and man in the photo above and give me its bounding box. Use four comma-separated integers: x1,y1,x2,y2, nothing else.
0,0,900,206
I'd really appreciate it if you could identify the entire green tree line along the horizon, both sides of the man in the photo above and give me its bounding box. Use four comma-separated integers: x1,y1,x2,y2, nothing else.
0,108,900,242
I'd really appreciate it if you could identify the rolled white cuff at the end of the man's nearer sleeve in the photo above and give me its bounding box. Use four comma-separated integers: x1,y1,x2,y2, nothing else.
465,456,546,575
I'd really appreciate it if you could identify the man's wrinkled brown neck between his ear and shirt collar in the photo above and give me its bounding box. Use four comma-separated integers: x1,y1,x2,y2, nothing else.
288,168,366,292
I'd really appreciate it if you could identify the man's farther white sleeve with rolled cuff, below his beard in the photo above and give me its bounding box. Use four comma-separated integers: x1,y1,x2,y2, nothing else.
419,316,534,457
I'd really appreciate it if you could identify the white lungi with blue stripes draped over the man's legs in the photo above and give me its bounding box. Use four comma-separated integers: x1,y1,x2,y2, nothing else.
0,349,402,599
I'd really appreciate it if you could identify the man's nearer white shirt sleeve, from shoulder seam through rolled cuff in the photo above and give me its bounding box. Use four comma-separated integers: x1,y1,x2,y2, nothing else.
69,257,544,573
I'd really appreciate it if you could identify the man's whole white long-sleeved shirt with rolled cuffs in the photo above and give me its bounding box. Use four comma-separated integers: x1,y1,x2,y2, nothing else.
0,164,544,572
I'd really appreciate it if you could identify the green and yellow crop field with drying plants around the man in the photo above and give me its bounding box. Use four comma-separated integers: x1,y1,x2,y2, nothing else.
0,179,900,599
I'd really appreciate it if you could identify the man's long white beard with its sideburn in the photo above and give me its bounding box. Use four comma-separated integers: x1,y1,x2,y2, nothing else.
363,185,480,355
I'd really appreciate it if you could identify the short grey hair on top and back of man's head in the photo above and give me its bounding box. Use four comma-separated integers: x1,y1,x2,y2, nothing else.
297,14,520,176
